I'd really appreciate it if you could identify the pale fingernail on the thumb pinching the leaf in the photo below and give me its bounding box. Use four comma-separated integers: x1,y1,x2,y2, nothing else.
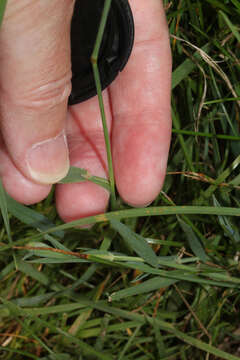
26,133,69,184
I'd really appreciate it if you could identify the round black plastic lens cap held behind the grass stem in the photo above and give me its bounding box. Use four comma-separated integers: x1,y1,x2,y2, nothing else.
69,0,134,105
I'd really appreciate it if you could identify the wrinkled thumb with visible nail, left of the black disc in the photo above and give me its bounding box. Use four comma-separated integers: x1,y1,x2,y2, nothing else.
0,0,74,184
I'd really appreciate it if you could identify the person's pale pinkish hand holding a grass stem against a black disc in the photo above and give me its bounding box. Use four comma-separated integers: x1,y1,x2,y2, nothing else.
0,0,171,221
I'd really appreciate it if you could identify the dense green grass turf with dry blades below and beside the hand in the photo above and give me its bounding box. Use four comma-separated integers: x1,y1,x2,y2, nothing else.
0,0,240,360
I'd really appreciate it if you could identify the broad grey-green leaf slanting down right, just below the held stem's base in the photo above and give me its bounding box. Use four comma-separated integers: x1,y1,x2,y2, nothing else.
110,219,158,267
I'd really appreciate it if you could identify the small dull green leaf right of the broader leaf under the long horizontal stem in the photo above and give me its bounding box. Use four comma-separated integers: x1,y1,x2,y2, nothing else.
178,217,207,262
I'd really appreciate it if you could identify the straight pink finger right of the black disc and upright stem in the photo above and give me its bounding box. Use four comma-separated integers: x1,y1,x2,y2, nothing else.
109,0,171,206
